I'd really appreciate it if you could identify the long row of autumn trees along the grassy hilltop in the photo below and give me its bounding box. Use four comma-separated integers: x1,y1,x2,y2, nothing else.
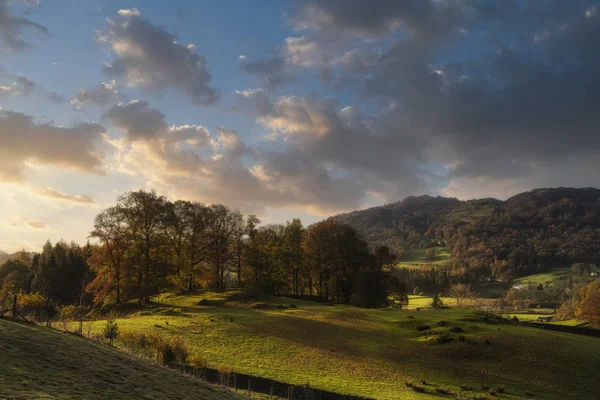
0,190,406,307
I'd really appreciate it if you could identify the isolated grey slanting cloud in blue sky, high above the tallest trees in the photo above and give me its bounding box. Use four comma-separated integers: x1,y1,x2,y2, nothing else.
98,9,219,106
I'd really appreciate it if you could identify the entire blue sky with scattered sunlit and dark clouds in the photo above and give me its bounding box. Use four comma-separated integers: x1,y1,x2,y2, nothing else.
0,0,600,251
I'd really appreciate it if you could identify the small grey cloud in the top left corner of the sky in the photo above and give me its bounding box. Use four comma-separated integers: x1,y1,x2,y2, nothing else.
0,0,49,52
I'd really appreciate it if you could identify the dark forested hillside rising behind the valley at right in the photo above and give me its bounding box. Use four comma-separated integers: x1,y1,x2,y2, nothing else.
334,188,600,281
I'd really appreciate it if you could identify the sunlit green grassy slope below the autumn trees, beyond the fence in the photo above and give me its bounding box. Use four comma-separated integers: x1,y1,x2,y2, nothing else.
74,294,600,399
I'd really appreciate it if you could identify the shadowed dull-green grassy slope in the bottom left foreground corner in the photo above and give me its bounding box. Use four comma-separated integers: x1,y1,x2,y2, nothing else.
0,320,248,400
